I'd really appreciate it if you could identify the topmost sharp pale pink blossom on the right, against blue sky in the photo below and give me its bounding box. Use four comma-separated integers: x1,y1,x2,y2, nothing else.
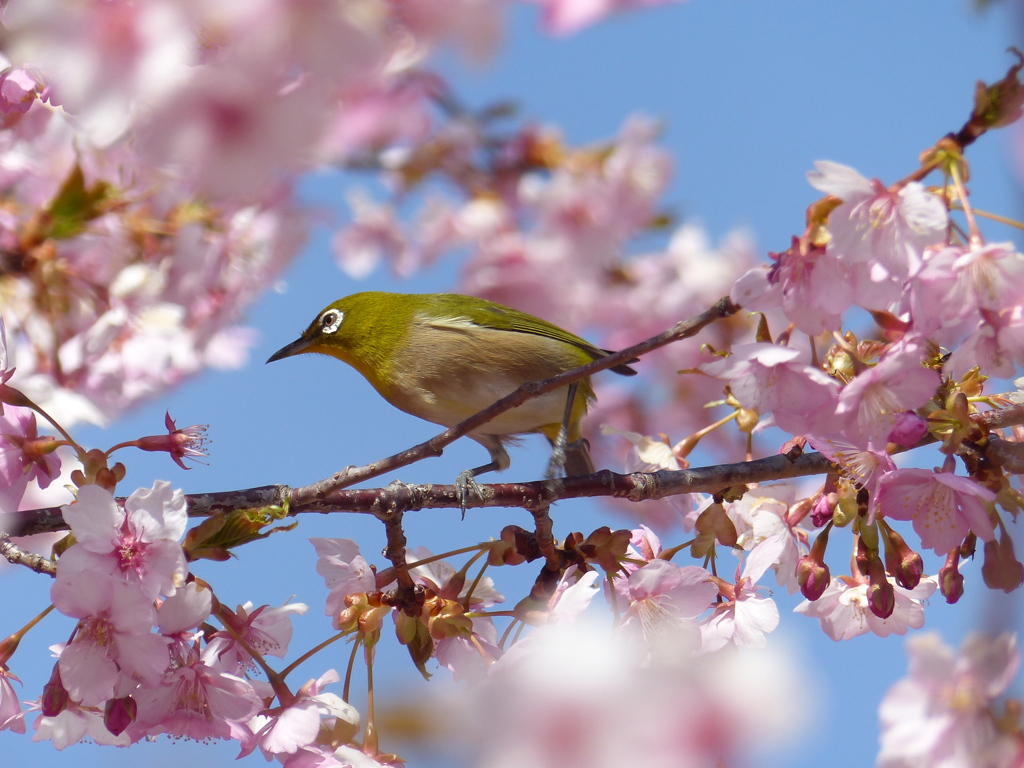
807,161,949,282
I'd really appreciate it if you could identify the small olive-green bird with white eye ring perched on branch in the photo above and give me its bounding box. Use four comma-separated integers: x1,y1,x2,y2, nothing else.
267,291,636,483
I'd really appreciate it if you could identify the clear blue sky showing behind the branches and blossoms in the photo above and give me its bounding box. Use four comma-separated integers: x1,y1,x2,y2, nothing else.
0,0,1021,768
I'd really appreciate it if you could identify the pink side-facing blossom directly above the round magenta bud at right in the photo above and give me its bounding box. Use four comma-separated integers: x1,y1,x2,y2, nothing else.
835,342,940,442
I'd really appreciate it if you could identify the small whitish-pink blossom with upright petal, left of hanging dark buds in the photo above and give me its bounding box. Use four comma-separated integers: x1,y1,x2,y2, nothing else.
700,535,786,653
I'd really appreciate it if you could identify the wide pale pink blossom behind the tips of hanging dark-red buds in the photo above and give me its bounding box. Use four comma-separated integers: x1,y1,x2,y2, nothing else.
794,577,938,641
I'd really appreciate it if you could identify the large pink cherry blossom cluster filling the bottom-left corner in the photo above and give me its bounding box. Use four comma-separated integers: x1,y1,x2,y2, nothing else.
0,481,397,766
